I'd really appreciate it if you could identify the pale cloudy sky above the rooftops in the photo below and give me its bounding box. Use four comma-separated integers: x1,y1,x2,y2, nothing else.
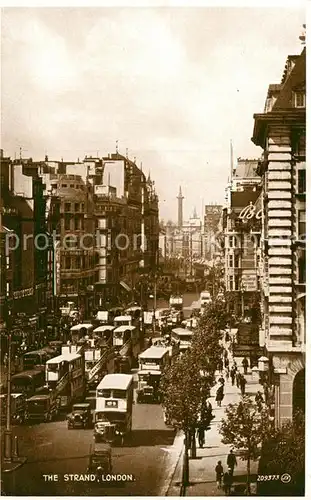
1,7,305,220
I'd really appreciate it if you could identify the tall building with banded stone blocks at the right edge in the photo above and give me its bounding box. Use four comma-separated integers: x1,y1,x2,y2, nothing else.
252,48,306,425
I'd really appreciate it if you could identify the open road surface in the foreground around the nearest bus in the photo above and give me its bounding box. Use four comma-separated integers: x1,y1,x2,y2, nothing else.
5,376,175,496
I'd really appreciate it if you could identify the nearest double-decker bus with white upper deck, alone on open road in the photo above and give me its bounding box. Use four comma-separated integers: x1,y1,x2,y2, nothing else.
94,373,134,442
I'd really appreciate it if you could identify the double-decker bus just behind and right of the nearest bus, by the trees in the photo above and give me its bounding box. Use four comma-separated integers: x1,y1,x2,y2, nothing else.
137,346,170,403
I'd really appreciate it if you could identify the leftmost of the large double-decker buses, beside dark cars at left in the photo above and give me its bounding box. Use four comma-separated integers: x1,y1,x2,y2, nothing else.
45,352,85,408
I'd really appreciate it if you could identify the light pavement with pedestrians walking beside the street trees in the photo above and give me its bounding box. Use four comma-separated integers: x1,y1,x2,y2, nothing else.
166,359,262,496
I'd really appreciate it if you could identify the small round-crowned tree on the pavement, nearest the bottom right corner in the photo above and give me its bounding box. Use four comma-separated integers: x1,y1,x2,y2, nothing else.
219,396,271,494
